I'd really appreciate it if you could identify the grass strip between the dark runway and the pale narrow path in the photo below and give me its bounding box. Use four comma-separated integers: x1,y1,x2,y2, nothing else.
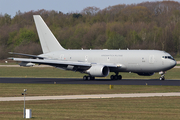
0,83,180,97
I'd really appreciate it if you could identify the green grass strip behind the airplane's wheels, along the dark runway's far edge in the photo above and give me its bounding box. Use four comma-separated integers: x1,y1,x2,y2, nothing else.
0,67,180,79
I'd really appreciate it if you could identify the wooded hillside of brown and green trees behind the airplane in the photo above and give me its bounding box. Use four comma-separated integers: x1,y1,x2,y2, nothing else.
0,1,180,59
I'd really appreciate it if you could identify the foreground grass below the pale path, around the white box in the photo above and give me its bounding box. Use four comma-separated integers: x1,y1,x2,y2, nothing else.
0,97,180,120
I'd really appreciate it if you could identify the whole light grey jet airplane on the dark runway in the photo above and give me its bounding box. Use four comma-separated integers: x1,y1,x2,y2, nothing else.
10,15,176,80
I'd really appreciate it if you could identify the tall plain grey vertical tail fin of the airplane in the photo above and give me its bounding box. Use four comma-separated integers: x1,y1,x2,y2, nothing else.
33,15,65,53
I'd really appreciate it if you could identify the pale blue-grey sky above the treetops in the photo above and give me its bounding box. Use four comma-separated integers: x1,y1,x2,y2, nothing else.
0,0,166,17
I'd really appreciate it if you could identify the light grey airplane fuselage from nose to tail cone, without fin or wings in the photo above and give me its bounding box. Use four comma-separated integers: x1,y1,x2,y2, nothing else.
40,50,176,73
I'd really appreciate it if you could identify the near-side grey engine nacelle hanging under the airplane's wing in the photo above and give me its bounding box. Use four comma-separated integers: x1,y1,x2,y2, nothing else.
86,65,109,77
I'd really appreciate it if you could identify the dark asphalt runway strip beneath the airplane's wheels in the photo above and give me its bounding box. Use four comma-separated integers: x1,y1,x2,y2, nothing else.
0,78,180,86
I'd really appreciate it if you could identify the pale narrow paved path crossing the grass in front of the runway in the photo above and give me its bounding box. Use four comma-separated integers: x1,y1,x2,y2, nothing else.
0,92,180,101
